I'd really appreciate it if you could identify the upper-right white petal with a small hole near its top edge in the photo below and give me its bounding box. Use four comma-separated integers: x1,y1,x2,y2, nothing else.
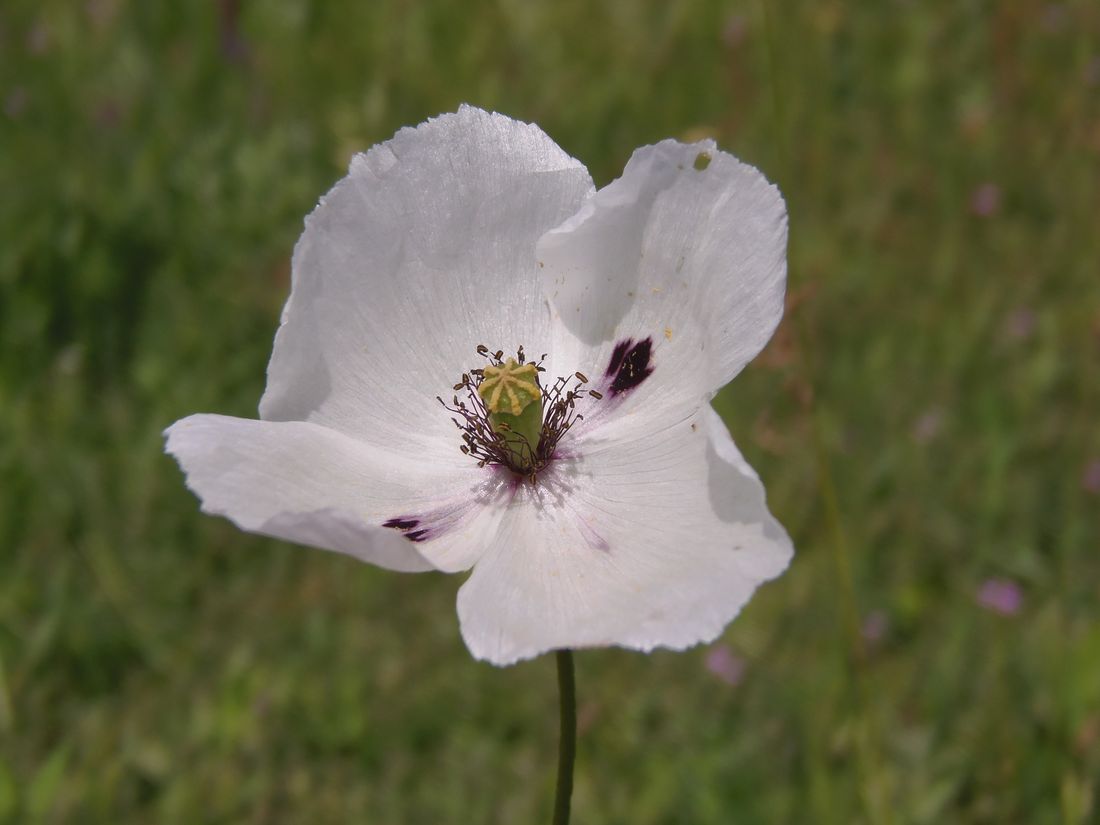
537,141,787,420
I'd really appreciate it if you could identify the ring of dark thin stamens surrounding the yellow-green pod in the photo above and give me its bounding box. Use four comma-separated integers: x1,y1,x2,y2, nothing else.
437,345,603,483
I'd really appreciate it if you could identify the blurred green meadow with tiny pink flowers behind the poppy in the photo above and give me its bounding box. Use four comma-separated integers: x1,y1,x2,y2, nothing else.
0,0,1100,825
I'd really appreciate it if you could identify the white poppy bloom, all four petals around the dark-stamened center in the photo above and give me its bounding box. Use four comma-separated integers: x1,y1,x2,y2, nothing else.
166,107,792,664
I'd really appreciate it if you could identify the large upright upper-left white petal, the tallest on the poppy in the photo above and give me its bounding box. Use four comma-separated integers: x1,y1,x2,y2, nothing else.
260,107,592,453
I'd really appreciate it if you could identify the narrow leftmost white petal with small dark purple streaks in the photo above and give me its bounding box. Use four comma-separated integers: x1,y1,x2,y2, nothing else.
165,415,508,572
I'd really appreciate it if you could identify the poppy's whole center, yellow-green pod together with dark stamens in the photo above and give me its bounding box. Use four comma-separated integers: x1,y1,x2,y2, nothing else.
437,345,603,483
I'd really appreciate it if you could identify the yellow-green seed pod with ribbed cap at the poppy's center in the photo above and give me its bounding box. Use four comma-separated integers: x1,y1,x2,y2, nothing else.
477,359,542,466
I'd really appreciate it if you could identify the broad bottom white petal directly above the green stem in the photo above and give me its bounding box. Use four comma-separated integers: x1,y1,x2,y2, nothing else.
459,406,792,664
